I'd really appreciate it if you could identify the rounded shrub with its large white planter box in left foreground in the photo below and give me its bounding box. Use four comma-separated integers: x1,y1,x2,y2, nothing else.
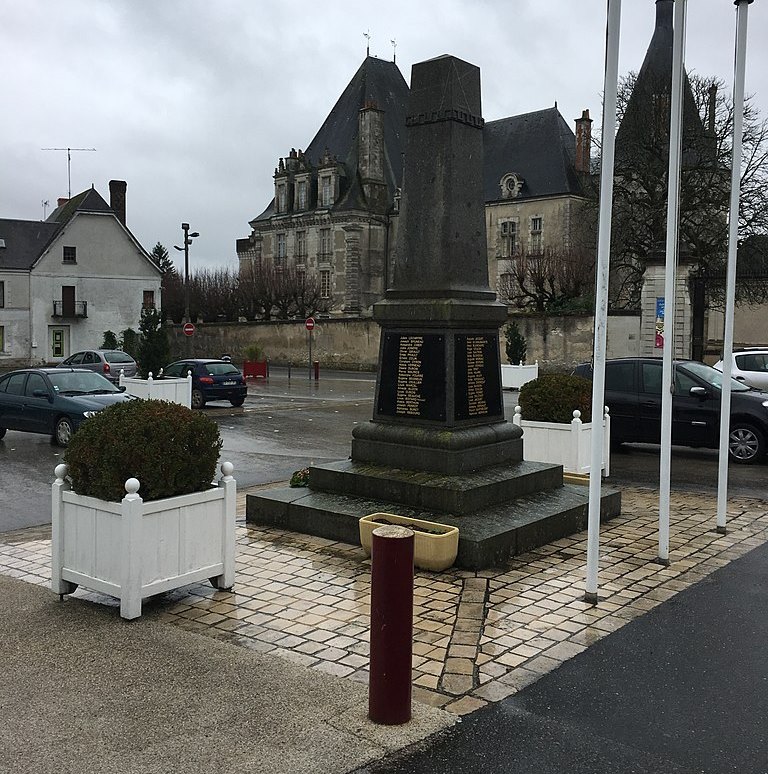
51,400,236,619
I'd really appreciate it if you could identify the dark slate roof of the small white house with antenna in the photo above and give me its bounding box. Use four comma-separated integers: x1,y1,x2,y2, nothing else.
0,188,114,269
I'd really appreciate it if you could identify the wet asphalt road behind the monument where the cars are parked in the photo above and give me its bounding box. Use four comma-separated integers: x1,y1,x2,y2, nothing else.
0,369,768,532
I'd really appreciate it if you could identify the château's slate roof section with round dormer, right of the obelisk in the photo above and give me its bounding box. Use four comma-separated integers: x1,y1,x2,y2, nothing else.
483,107,583,202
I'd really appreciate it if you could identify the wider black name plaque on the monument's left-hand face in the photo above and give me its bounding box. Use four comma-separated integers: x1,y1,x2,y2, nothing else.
377,333,445,421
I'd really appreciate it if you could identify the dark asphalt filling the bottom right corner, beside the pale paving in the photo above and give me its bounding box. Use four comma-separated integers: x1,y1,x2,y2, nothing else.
358,532,768,774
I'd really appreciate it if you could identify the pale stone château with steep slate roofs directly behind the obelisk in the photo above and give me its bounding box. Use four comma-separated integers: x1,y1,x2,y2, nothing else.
237,56,591,316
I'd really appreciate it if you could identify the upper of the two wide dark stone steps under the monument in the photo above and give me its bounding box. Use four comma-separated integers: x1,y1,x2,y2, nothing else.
309,460,563,515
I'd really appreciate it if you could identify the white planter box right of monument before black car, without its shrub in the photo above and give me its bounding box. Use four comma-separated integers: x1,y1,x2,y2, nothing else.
513,406,611,476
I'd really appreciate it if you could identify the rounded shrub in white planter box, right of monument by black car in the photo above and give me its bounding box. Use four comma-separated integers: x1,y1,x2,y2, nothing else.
513,374,611,480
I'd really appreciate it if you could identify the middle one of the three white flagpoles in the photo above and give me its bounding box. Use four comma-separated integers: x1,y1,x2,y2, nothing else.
657,0,687,564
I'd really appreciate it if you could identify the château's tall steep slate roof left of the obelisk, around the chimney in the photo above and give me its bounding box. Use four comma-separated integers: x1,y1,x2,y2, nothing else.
255,56,408,220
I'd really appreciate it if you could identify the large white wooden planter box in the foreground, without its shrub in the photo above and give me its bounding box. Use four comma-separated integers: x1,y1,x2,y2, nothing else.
51,462,237,619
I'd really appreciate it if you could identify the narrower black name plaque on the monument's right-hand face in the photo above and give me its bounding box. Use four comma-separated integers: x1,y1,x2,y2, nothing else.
454,333,502,419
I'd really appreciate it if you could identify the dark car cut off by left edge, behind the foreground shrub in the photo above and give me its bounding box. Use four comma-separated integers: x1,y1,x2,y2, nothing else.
0,367,134,446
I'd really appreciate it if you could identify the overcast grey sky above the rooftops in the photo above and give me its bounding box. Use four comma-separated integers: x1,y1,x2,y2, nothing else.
0,0,768,269
